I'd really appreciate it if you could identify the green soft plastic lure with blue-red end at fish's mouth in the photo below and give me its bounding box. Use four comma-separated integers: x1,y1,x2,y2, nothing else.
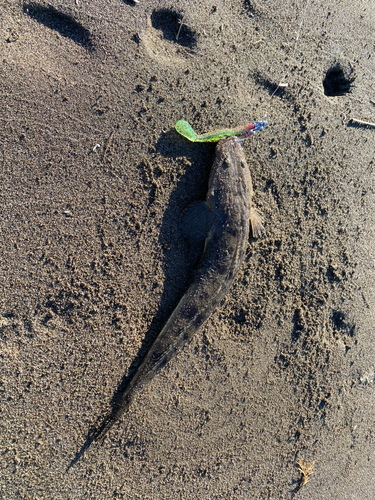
175,117,267,142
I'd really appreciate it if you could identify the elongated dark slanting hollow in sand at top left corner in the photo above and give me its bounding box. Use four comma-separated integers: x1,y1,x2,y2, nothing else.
23,3,93,50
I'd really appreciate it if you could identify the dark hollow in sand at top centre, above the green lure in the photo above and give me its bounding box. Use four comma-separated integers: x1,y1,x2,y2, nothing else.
151,9,197,49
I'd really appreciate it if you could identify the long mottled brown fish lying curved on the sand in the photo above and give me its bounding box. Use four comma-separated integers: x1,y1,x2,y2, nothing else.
93,137,263,440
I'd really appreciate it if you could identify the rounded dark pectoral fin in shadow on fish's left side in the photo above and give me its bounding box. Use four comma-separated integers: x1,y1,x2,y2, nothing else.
180,201,212,246
